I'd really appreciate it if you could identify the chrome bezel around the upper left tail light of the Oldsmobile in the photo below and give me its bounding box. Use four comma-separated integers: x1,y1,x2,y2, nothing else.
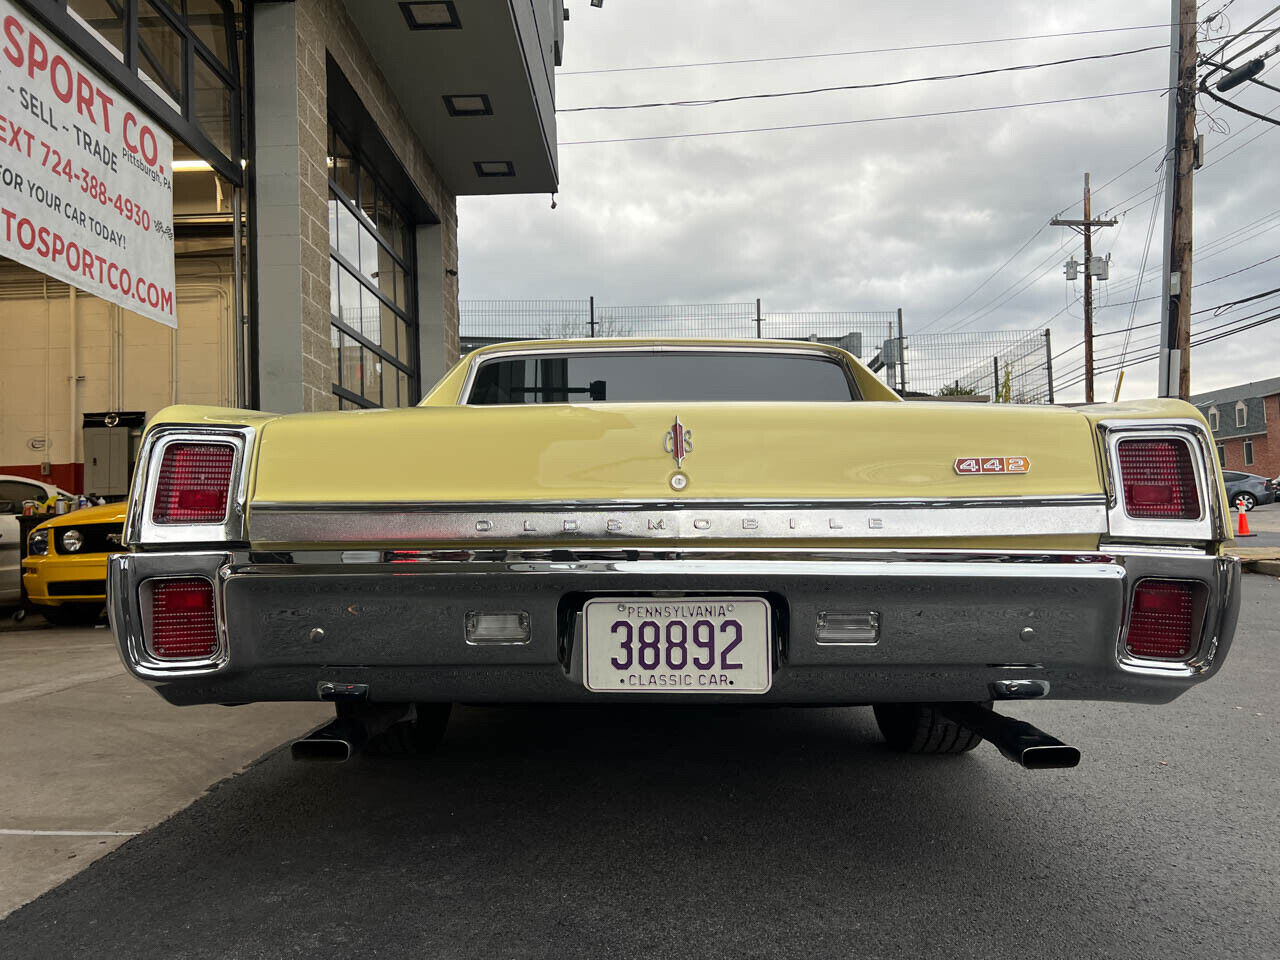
123,425,256,547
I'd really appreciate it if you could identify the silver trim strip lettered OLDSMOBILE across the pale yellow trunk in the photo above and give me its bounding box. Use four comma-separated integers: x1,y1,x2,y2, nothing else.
250,495,1107,547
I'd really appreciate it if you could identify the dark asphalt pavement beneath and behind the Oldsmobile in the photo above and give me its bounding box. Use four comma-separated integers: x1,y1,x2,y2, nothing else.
0,576,1280,960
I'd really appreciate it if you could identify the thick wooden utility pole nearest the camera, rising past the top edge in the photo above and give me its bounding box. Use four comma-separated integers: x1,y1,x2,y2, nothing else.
1158,0,1197,399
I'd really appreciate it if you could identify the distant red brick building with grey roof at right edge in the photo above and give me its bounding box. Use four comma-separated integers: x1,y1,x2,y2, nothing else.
1192,376,1280,477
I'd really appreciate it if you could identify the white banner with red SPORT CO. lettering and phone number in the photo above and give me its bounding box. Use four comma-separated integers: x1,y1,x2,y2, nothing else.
0,0,178,326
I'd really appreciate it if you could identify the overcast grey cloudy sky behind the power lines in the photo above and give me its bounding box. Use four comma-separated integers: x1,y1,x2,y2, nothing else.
458,0,1280,399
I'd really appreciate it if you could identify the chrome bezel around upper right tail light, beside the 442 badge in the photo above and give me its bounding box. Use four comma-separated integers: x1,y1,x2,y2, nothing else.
1098,419,1230,543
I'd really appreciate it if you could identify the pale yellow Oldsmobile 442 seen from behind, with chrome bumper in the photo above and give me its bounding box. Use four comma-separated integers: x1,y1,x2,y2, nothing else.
108,339,1239,768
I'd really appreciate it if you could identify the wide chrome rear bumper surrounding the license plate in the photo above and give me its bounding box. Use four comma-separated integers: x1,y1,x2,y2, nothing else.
108,547,1239,704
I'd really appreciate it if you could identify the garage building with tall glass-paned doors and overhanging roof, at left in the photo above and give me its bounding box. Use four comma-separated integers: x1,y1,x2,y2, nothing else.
0,0,567,495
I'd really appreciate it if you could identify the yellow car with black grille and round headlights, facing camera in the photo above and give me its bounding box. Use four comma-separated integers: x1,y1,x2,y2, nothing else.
22,503,127,626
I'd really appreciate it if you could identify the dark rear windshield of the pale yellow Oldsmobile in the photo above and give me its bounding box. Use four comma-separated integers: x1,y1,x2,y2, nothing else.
467,349,858,404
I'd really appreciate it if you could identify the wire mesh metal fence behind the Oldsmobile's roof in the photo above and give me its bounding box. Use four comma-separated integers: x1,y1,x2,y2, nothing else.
460,297,1053,403
